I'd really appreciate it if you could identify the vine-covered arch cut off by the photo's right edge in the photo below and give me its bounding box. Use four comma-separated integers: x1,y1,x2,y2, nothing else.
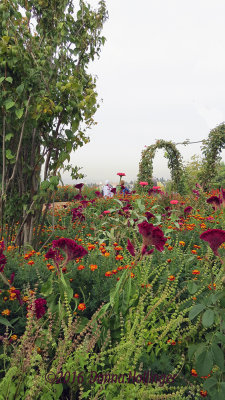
199,123,225,189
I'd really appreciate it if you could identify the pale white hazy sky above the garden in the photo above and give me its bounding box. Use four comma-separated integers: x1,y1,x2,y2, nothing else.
63,0,225,183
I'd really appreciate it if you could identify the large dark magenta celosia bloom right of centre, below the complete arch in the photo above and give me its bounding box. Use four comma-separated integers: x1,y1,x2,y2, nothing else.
138,221,166,251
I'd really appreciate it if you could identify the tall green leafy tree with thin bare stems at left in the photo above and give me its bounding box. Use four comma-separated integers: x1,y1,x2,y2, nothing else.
0,0,107,245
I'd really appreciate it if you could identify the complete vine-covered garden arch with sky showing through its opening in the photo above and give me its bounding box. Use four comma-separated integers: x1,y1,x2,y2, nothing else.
138,139,183,191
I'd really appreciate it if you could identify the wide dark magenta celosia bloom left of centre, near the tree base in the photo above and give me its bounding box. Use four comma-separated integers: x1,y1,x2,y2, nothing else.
52,238,88,264
